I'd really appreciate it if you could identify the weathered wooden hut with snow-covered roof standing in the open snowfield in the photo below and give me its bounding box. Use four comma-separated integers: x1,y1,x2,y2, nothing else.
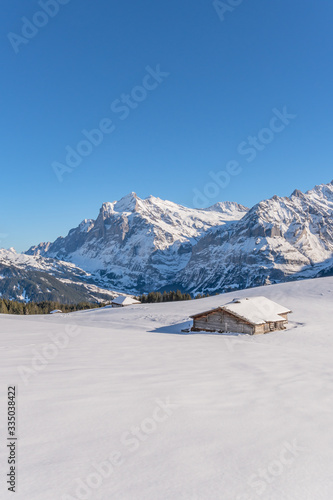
191,297,291,335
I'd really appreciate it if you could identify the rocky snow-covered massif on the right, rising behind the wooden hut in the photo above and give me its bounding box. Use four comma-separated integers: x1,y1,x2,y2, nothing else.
178,183,333,292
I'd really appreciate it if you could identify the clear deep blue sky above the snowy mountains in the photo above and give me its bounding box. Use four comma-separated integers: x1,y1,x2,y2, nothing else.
0,0,333,250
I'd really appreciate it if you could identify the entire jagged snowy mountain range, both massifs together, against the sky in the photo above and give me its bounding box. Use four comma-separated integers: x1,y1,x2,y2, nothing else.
27,183,333,293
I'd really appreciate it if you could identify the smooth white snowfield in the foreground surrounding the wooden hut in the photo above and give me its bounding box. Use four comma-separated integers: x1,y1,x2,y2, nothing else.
0,278,333,500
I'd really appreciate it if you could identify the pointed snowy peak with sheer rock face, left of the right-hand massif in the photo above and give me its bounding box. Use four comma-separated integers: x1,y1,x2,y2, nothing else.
28,193,248,292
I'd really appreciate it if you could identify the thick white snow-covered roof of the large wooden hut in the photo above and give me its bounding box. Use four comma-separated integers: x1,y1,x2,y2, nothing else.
222,297,291,325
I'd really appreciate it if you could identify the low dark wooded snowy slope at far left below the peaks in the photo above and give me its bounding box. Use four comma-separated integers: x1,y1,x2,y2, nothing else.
0,249,124,303
